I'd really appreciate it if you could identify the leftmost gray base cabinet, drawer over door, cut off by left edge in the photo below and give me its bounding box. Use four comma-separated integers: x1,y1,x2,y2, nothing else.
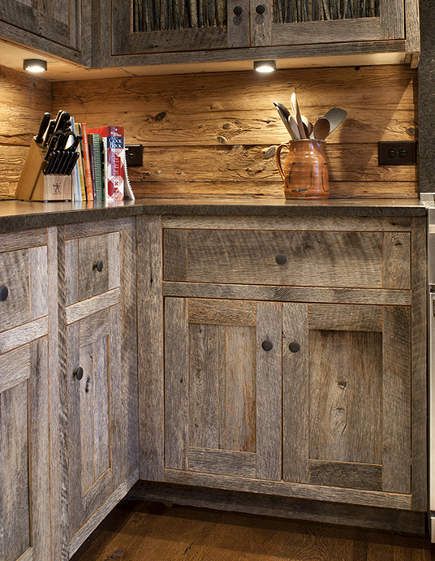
0,229,51,561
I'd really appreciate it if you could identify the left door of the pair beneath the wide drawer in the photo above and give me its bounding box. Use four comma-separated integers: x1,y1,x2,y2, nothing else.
165,298,281,480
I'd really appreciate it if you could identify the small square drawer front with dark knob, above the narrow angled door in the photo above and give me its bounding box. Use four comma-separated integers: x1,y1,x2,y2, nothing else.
65,232,120,305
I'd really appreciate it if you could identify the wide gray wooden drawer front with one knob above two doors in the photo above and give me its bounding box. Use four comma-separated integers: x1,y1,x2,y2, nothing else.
164,229,410,289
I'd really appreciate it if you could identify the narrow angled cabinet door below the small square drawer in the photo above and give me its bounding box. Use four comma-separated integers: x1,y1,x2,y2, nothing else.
66,306,126,541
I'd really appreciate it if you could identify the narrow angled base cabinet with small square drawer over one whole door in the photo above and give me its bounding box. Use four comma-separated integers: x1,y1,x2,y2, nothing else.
64,219,138,555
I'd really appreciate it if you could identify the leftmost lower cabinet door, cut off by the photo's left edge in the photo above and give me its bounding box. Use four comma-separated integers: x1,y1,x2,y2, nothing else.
0,338,50,561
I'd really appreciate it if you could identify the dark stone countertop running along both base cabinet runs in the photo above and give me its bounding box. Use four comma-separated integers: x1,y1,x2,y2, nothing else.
0,196,426,233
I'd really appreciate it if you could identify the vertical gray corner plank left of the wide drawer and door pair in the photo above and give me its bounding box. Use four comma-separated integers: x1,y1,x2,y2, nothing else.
136,216,164,481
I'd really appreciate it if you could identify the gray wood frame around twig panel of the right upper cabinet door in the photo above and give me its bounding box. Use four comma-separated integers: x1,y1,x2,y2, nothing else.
251,0,406,47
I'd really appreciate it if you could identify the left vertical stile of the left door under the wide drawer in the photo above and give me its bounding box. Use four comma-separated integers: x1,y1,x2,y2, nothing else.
165,298,190,469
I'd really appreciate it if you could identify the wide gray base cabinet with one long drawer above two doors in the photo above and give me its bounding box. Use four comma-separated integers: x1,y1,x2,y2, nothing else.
138,216,427,512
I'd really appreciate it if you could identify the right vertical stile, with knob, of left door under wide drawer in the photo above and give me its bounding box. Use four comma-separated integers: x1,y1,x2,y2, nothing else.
256,302,282,480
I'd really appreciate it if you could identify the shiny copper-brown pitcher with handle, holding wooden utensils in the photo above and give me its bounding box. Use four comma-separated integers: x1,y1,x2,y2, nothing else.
276,140,329,199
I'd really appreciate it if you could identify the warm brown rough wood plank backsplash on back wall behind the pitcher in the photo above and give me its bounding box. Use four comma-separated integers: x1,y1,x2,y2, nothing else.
53,66,417,197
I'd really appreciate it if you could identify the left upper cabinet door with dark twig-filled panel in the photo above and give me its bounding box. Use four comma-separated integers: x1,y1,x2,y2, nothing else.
110,0,249,55
